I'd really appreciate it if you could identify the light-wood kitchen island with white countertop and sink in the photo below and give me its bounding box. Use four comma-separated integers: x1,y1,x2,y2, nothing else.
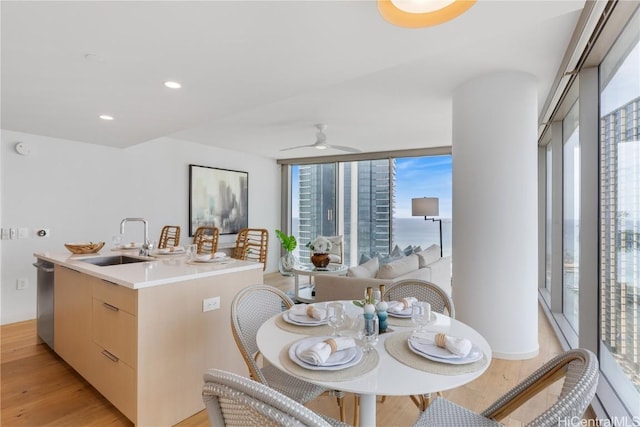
34,250,263,426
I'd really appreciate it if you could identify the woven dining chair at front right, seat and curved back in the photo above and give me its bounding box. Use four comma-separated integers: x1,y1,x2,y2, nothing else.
414,349,599,427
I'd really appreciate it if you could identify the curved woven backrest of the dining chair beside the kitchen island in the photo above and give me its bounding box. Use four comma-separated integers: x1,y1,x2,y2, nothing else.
231,285,293,385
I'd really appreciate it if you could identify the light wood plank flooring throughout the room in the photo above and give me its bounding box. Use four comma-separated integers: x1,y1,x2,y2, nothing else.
0,273,592,427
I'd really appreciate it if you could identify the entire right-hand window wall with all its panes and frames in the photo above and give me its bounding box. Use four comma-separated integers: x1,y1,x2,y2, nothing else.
539,2,640,420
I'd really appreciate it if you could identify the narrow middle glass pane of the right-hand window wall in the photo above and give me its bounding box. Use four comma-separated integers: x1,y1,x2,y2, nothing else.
562,102,580,333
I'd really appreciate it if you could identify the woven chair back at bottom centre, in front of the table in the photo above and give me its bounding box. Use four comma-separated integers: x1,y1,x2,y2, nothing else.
202,369,330,427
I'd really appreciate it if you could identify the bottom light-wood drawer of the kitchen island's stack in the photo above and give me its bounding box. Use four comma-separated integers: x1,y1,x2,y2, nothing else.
90,344,137,423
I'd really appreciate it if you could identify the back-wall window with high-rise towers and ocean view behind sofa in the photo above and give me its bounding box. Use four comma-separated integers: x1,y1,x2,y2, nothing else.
286,153,451,265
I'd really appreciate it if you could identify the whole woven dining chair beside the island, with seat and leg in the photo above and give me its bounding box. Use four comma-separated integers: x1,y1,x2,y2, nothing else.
231,285,345,421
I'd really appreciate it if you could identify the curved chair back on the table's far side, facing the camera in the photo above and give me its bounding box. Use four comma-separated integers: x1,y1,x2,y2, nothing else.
382,279,456,318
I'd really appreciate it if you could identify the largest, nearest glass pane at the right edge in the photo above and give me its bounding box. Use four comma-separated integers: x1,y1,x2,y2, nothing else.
600,6,640,414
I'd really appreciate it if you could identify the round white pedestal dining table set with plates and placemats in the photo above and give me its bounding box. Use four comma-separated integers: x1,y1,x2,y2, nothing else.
256,301,492,427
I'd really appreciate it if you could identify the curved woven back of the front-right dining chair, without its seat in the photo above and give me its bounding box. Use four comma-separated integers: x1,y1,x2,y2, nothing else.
481,348,599,427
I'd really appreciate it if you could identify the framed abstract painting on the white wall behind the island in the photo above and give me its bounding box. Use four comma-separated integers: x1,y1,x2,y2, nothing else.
189,165,249,236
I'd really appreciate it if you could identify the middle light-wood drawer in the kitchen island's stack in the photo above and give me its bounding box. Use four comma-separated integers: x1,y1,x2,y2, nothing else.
93,298,138,366
